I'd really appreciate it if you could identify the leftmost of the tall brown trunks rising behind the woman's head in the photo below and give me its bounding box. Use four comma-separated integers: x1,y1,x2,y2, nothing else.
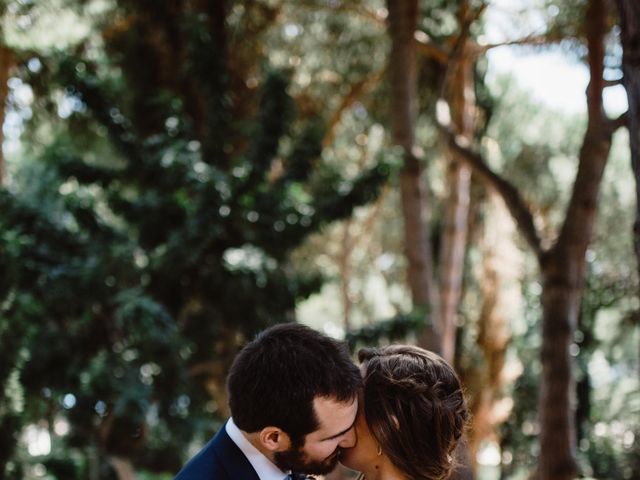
387,0,440,352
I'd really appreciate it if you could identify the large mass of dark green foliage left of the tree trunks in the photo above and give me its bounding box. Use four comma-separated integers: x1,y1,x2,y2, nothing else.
0,1,395,478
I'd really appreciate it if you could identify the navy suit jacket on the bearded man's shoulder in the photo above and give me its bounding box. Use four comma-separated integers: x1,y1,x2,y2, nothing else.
175,424,260,480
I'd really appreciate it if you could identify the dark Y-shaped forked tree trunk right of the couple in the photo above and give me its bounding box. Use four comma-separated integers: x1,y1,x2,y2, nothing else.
443,0,624,480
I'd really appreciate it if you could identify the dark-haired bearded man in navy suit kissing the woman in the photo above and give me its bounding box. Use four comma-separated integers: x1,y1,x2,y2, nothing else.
175,323,362,480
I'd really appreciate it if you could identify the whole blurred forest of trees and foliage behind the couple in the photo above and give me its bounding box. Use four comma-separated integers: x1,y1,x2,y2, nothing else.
0,0,640,480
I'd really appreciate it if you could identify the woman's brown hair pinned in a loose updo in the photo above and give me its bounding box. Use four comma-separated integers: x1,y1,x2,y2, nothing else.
358,345,469,480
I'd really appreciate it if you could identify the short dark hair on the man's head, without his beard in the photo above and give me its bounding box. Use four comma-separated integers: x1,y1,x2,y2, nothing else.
227,323,362,443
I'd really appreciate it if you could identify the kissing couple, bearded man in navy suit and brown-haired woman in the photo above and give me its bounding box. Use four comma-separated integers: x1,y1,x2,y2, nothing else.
175,323,469,480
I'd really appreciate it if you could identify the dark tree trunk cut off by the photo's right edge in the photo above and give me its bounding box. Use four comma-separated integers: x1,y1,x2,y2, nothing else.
617,0,640,300
